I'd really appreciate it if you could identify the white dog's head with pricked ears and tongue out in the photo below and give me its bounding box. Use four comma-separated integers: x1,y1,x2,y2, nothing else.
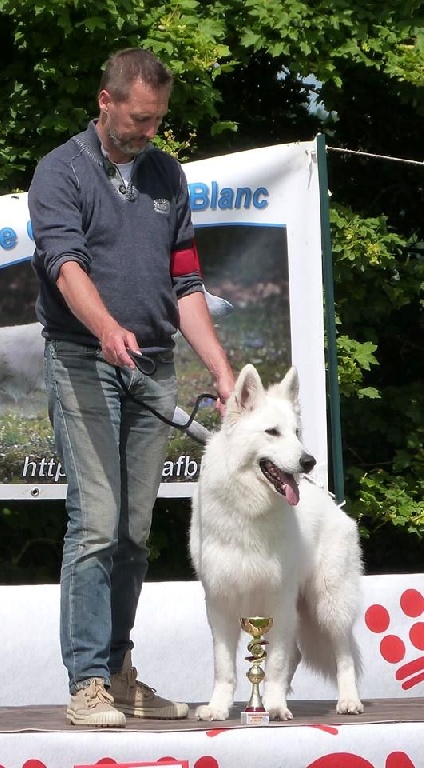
223,364,316,506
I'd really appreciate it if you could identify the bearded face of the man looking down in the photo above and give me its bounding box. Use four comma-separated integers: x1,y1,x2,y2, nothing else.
97,80,170,163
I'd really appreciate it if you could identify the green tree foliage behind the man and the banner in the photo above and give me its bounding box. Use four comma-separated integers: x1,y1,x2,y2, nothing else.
0,0,424,576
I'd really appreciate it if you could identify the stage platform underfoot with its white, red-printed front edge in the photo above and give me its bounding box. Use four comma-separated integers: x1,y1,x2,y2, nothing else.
0,698,424,768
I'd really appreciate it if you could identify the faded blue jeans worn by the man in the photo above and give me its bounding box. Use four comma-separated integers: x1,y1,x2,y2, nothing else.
45,341,177,693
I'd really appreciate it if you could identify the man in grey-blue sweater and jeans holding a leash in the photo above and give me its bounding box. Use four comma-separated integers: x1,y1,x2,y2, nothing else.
28,49,233,726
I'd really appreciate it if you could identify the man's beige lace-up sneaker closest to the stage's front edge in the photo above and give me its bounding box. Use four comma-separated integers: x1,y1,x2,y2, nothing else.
66,677,126,728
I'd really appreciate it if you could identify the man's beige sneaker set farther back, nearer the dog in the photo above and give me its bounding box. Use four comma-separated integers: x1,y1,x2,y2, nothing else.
110,651,188,720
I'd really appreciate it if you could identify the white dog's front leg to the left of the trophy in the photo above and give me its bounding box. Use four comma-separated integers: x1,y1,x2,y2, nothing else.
196,601,240,720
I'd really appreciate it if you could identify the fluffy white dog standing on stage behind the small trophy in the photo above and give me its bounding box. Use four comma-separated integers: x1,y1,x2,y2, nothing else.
190,365,363,720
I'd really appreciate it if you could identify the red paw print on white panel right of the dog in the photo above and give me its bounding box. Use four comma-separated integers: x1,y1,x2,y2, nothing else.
365,589,424,691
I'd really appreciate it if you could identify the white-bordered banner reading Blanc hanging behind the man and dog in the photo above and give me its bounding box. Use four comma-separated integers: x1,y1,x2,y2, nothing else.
0,141,327,499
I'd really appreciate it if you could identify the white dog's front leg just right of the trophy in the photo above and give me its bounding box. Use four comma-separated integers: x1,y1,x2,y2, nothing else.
263,608,300,720
